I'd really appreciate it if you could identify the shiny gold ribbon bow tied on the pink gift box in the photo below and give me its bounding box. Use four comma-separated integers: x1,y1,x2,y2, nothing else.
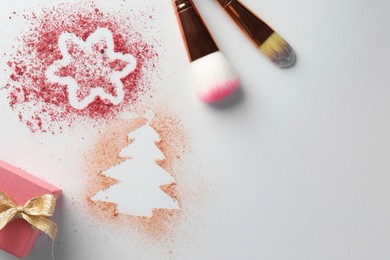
0,191,57,258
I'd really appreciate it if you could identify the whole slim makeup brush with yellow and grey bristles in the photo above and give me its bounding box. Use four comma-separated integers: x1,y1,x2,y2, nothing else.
217,0,296,68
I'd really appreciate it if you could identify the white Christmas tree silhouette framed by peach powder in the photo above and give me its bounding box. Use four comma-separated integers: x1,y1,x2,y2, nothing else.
92,123,179,217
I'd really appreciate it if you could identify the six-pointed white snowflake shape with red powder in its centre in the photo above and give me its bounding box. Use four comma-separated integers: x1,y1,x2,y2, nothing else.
46,28,137,110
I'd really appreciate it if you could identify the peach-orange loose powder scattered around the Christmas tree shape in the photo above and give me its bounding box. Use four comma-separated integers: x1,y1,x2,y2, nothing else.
85,111,189,240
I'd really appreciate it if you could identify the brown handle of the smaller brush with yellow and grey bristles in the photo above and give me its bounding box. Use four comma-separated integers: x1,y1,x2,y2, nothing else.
217,0,274,46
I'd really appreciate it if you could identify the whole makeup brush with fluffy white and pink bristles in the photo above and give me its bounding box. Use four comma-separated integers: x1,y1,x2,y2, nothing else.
173,0,240,103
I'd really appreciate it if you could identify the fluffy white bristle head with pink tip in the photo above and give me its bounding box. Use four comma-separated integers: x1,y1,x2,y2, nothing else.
191,51,240,103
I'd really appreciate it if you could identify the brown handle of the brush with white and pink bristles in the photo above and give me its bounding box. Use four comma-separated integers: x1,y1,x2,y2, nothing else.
174,0,219,62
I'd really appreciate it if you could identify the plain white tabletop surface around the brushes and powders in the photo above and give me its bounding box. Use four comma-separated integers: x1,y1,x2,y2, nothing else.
0,0,390,260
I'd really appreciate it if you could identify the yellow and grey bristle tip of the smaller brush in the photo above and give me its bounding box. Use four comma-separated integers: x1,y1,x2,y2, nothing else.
260,32,296,68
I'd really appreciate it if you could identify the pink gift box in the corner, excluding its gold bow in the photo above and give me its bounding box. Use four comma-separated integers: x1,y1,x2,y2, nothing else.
0,160,61,258
